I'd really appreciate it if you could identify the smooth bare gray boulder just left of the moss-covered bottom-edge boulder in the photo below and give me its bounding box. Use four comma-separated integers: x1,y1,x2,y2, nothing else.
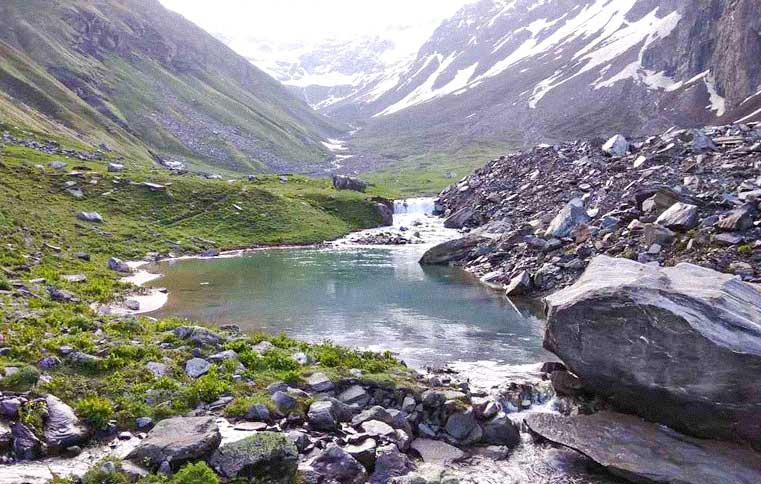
127,417,222,467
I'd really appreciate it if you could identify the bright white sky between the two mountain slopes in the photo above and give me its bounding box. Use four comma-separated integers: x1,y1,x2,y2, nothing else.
161,0,472,43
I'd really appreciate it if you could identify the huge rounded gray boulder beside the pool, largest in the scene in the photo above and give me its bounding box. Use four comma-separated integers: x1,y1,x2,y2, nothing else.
544,256,761,441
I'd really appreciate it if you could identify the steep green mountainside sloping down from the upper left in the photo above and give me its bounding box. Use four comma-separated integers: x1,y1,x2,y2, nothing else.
0,0,338,173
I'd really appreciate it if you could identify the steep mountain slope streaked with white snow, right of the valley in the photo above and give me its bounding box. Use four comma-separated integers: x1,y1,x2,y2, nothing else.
334,0,761,156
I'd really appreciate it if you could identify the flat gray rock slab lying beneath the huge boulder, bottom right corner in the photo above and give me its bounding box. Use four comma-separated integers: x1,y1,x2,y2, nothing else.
526,412,761,484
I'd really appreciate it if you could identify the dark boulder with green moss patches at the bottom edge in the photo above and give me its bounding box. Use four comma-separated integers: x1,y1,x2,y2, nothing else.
209,432,299,484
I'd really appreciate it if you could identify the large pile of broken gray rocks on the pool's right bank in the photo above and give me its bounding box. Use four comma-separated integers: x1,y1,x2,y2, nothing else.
424,123,761,295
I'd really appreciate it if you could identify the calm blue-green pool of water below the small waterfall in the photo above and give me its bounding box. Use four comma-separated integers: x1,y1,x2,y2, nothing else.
148,245,548,366
